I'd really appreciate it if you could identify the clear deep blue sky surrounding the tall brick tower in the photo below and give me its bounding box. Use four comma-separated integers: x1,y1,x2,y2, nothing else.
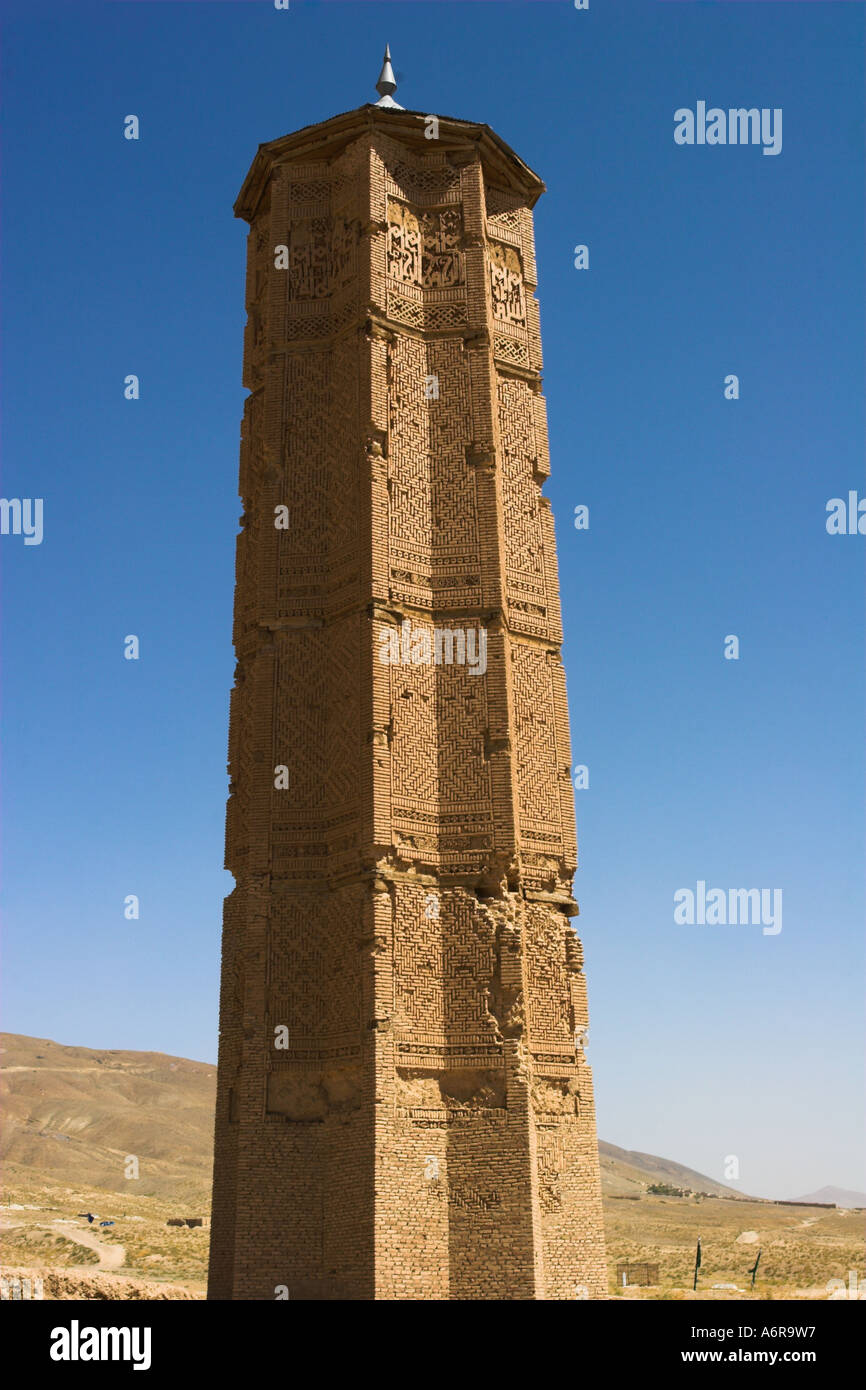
0,0,866,1197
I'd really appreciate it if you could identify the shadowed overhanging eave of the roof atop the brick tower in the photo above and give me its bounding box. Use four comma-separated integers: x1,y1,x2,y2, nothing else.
235,103,545,222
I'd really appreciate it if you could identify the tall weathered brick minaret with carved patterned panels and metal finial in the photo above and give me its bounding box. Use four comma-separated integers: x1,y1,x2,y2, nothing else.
210,48,606,1300
